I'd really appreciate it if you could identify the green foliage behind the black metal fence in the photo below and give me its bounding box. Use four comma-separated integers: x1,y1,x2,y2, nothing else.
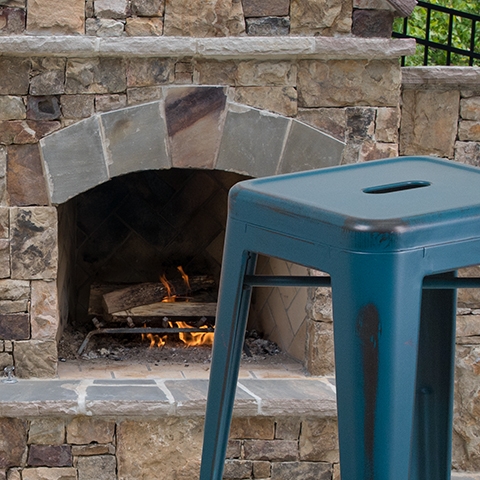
393,0,480,66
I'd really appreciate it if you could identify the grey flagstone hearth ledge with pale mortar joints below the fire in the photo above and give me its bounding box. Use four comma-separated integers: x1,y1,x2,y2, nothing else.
0,377,336,417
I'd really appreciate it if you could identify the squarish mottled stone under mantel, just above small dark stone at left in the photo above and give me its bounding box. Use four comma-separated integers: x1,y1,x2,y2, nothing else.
29,57,65,95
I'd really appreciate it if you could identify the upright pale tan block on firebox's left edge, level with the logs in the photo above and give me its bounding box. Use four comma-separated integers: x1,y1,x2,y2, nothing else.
30,280,59,340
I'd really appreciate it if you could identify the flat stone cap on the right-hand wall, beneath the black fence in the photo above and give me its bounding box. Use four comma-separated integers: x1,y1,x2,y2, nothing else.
402,67,480,89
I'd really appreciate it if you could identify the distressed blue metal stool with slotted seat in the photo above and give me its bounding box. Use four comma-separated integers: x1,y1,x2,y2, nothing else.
200,157,480,480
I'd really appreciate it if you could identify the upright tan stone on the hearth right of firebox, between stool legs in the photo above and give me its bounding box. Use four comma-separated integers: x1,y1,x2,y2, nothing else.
306,320,335,375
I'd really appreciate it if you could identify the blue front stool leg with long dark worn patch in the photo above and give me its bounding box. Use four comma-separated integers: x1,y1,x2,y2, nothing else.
331,252,422,480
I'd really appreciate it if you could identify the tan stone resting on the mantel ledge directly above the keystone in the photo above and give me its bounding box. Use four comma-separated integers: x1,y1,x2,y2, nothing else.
164,0,245,37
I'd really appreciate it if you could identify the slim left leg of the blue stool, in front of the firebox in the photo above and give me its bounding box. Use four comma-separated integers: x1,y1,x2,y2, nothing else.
200,238,257,480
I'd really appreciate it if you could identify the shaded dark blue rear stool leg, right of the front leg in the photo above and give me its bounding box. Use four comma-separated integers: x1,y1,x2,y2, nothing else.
410,273,456,480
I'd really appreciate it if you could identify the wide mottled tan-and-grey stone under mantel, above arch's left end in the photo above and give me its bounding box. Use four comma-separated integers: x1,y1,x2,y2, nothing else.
65,58,127,94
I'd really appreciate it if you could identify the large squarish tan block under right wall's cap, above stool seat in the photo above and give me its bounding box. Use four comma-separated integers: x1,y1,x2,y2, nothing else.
400,90,460,158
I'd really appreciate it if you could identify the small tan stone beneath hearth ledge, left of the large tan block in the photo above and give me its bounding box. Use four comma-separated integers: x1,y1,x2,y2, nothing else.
67,417,115,445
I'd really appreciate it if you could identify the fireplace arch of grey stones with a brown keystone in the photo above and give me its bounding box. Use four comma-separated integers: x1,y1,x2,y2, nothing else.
40,86,344,205
